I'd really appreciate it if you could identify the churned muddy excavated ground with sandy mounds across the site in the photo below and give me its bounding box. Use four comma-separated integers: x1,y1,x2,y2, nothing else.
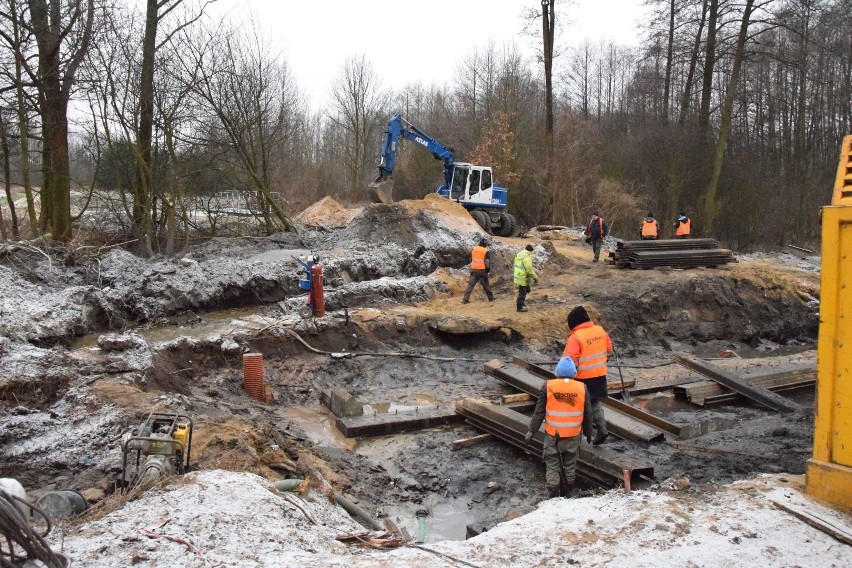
0,198,819,539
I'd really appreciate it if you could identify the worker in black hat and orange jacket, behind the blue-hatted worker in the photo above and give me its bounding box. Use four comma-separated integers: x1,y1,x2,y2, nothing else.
562,306,612,446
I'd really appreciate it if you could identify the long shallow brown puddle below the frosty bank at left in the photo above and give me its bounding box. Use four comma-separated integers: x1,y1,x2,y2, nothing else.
71,307,267,349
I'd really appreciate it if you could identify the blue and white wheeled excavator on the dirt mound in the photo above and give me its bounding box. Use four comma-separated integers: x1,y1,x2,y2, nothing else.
370,114,517,237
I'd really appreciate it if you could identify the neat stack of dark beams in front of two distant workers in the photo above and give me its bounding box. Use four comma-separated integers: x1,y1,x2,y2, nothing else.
610,239,736,268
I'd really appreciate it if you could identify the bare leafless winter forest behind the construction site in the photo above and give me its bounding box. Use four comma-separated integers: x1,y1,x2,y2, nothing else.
0,0,852,256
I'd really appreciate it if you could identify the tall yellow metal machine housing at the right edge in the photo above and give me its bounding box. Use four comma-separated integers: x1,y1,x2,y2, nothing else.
807,136,852,509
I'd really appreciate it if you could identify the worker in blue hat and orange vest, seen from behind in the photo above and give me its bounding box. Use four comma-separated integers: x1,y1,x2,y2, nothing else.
524,357,592,498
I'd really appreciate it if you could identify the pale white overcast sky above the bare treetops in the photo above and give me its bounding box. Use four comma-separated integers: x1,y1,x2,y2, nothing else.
211,0,644,109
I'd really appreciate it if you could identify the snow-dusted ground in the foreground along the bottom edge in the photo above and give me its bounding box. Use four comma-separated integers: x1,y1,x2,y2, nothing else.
51,471,852,568
